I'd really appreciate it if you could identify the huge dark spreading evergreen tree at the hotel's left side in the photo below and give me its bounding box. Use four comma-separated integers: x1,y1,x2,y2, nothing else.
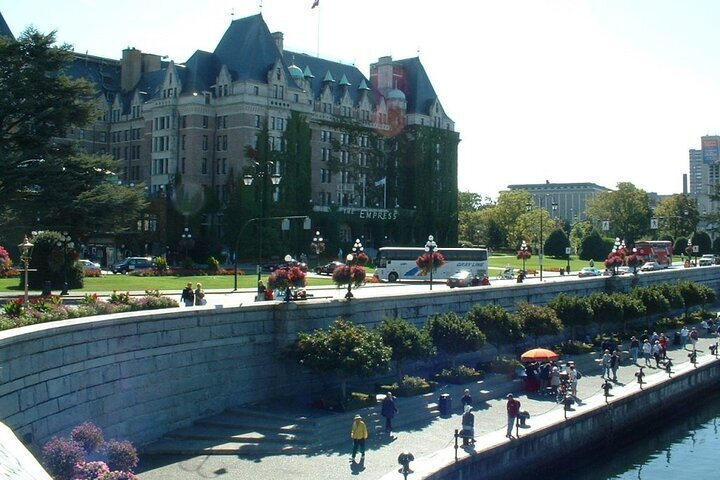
0,28,147,237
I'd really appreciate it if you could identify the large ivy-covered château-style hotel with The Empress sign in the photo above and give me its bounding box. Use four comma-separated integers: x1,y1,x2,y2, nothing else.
59,15,459,254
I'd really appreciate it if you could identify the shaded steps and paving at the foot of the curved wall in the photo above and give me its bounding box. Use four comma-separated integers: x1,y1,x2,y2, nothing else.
141,375,521,458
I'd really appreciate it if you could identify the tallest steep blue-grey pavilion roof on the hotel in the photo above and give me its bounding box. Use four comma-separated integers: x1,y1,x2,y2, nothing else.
214,14,291,82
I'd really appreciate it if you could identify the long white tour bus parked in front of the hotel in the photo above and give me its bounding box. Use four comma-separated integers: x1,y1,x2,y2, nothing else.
375,247,488,282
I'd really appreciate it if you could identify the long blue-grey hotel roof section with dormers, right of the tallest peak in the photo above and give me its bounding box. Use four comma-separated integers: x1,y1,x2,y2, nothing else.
285,51,370,103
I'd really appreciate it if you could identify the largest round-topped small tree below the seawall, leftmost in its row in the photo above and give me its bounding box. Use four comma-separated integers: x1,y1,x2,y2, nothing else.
290,318,392,400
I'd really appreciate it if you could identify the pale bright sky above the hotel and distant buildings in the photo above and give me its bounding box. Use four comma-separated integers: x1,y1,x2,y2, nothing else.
5,0,720,197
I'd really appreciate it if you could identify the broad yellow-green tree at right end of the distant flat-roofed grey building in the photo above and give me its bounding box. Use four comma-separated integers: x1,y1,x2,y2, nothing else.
587,182,652,244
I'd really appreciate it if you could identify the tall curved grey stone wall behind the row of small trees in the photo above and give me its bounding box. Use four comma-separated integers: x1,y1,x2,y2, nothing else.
0,267,720,458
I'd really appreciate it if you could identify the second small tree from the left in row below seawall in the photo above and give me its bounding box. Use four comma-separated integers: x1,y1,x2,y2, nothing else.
377,317,435,380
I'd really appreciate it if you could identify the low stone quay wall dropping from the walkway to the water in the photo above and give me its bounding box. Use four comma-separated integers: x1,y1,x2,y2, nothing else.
422,350,720,480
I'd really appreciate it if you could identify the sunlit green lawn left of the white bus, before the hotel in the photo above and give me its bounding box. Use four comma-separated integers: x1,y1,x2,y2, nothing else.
0,273,338,294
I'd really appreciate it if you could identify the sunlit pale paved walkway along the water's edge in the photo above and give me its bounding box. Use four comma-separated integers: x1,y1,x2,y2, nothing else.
138,330,715,480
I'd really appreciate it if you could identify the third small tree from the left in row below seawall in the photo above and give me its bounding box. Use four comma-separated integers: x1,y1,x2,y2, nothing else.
425,312,486,368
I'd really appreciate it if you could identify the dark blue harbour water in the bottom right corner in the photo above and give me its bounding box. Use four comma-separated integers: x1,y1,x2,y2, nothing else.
554,393,720,480
